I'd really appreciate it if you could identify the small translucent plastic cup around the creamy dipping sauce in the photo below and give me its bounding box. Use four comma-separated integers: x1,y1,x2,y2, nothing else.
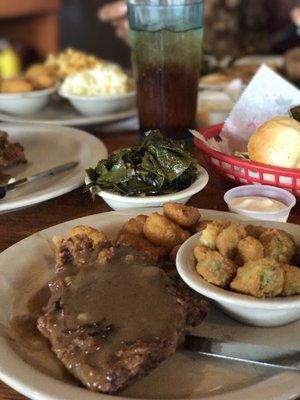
224,185,296,222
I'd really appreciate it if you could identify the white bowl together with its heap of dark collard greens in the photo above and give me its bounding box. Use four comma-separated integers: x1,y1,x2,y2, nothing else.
85,131,209,210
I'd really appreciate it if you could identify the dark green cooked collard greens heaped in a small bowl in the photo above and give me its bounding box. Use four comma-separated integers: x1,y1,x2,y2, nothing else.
87,130,198,196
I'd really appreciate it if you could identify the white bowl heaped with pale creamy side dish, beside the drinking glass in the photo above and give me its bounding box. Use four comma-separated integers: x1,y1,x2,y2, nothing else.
58,63,136,116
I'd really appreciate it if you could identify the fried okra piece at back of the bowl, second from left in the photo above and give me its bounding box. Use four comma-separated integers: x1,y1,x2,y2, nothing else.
216,223,247,260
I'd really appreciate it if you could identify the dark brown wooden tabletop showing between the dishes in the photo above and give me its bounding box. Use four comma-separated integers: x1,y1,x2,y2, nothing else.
0,132,300,400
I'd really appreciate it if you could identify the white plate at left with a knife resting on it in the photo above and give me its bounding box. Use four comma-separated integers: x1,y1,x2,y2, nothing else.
0,124,107,212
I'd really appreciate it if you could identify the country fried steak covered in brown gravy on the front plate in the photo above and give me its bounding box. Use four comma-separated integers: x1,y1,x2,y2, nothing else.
38,227,207,393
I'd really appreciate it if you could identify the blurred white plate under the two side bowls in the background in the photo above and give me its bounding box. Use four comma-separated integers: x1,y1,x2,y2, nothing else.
0,96,137,126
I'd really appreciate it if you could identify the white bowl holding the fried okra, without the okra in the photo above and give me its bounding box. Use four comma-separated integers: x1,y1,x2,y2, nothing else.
176,233,300,327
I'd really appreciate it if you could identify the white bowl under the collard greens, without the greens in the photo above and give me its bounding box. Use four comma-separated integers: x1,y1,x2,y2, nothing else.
85,165,209,211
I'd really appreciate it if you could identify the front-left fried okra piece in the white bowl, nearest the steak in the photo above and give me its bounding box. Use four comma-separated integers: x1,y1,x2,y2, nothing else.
194,245,236,288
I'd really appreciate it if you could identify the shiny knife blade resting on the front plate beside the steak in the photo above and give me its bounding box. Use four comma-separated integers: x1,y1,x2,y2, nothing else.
183,335,300,372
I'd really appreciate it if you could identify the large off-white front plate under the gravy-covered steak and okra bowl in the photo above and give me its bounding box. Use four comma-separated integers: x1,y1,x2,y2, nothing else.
0,209,300,400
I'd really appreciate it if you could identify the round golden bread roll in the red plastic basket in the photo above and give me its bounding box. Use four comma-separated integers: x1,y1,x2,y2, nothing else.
248,117,300,168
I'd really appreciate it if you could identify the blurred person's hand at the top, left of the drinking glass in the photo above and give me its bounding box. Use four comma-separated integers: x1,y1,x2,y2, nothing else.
98,0,129,43
